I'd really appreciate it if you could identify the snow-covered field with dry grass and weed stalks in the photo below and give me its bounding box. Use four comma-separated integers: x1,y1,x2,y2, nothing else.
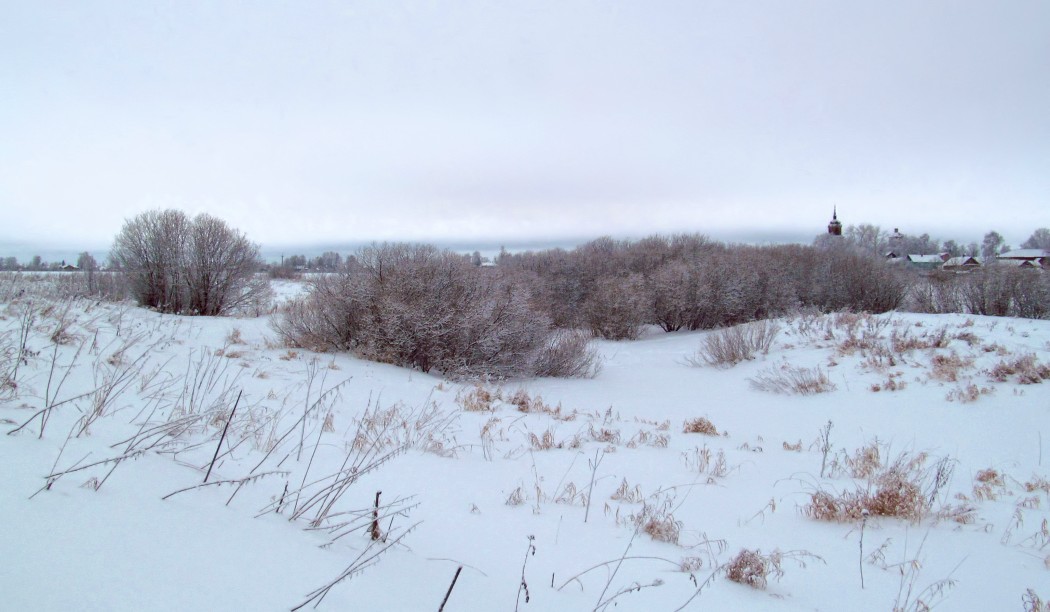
0,279,1050,611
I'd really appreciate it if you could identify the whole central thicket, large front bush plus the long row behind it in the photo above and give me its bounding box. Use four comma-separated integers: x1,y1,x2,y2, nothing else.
273,236,907,378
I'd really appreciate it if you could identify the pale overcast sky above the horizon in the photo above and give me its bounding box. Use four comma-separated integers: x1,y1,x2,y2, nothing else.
0,0,1050,249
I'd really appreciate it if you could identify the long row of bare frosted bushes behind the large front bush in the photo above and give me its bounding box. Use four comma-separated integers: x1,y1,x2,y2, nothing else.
500,236,909,339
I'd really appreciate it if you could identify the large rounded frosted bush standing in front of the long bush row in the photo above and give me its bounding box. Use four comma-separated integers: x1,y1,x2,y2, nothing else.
273,244,594,378
